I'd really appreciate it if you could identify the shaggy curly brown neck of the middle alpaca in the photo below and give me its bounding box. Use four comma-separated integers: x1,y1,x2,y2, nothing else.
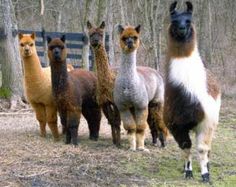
93,45,112,87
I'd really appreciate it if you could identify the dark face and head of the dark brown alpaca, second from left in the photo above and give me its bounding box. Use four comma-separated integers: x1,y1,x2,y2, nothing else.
47,35,67,62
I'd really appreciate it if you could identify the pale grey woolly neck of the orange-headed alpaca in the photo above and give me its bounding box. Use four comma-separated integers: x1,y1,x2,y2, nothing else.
120,50,137,78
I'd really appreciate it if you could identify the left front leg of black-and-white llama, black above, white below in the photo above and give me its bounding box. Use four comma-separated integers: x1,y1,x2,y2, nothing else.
171,125,193,179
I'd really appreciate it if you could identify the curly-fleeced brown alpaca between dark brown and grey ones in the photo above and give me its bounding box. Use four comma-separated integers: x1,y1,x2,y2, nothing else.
87,21,121,146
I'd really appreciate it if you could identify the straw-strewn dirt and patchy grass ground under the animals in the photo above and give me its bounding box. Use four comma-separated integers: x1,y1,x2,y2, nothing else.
0,99,236,187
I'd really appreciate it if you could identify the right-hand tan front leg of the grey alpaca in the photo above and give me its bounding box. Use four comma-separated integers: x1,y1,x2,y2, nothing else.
135,109,149,151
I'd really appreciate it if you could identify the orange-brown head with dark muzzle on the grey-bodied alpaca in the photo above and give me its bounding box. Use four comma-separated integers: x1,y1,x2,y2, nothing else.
118,25,141,53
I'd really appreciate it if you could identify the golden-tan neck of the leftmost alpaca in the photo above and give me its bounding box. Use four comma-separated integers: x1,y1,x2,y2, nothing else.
22,54,43,83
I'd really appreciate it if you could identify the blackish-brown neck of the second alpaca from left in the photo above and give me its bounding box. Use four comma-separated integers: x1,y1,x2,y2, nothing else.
50,61,68,96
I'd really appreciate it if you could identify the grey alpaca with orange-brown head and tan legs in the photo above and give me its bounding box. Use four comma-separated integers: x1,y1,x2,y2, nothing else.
114,25,166,151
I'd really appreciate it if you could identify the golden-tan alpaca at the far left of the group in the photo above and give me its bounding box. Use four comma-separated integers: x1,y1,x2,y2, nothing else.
18,33,59,140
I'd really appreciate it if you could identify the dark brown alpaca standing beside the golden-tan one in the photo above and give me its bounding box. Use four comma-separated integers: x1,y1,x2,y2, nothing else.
47,35,101,145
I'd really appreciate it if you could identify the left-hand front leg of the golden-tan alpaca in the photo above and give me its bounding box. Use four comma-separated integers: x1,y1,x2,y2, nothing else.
31,103,47,137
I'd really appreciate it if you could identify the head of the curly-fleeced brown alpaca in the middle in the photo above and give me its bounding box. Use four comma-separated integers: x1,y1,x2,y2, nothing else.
87,21,105,47
